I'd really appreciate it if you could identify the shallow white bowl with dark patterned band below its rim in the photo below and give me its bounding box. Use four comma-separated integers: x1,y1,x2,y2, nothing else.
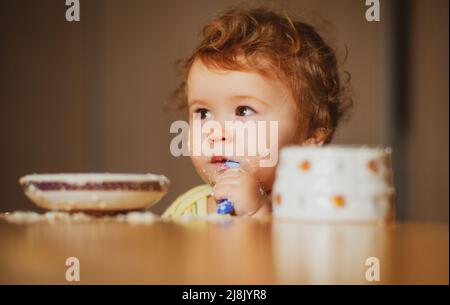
19,173,169,213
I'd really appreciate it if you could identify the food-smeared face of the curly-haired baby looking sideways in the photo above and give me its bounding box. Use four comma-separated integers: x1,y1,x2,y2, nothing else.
187,60,299,190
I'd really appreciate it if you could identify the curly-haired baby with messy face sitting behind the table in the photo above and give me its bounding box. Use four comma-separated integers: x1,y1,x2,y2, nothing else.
163,8,352,217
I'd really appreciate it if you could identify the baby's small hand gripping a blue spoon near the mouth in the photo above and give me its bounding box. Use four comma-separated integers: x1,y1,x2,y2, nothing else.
212,168,271,215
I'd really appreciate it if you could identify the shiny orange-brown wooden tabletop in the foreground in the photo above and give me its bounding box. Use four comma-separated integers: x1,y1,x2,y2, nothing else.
0,218,449,284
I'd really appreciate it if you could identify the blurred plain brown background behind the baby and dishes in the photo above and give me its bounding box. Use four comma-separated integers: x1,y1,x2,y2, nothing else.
0,0,449,218
